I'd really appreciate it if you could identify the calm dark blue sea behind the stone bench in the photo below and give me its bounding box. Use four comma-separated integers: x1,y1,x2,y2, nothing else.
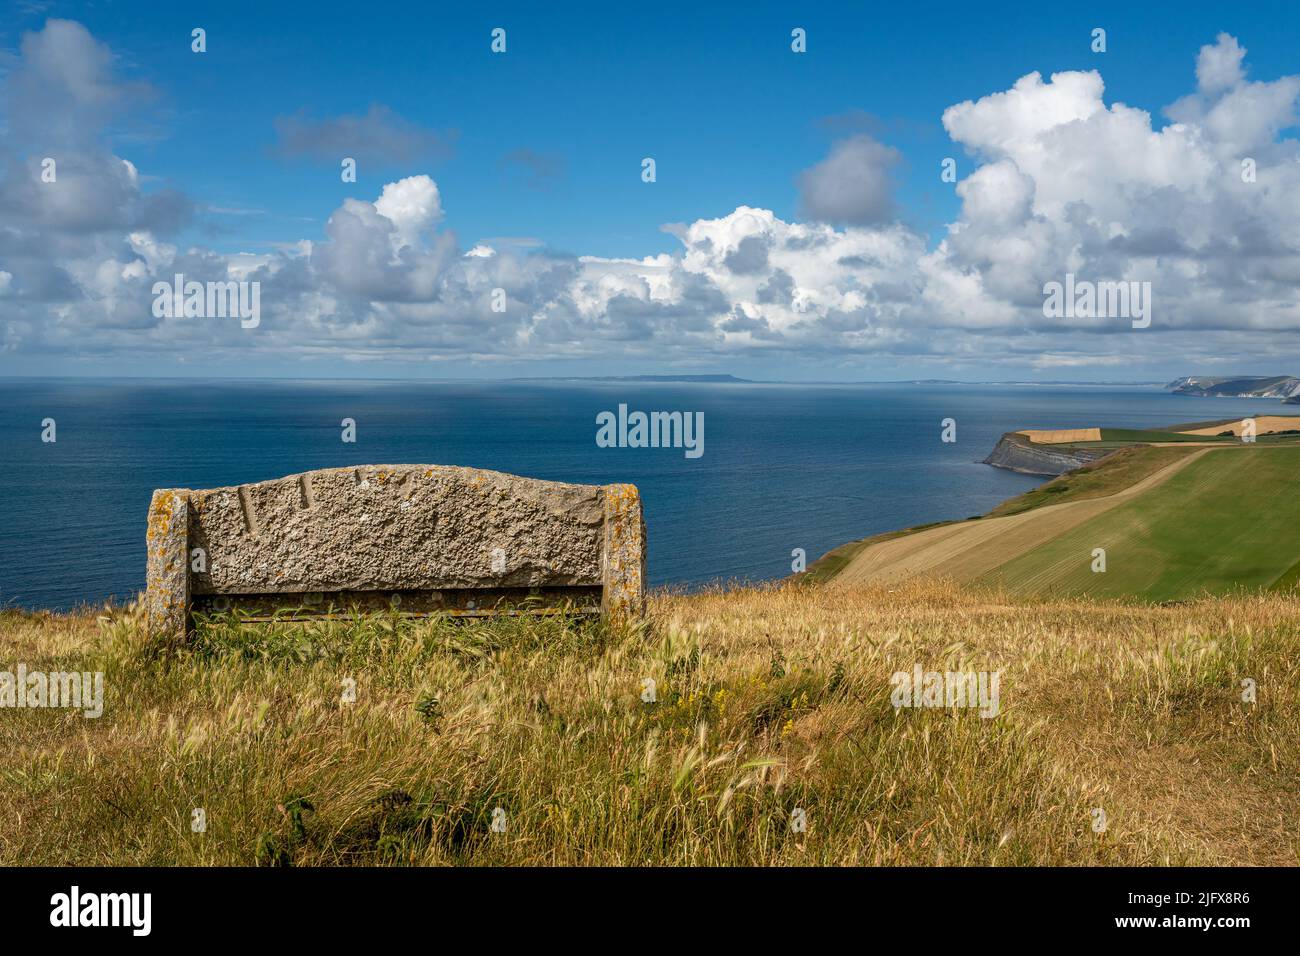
0,378,1283,609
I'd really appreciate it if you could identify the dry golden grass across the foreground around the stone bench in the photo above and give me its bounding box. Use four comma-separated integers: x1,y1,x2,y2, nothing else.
0,583,1300,865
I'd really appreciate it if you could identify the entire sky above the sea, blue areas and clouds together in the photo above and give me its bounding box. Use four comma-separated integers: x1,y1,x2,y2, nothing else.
0,0,1300,381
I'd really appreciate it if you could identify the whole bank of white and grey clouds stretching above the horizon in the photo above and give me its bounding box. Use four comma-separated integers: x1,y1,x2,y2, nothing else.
0,21,1300,372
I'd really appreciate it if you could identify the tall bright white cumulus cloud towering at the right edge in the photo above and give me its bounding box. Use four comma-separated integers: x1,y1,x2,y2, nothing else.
922,34,1300,347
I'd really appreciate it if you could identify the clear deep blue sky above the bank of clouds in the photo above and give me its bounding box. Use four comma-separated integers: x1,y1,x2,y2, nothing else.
58,3,1300,256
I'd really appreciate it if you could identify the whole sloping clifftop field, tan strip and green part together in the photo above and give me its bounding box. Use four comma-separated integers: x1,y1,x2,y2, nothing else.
832,442,1300,601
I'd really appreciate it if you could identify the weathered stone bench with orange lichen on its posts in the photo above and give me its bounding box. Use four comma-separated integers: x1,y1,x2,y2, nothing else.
146,464,645,637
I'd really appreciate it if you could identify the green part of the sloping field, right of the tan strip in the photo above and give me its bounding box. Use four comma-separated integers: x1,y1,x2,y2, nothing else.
984,447,1300,601
